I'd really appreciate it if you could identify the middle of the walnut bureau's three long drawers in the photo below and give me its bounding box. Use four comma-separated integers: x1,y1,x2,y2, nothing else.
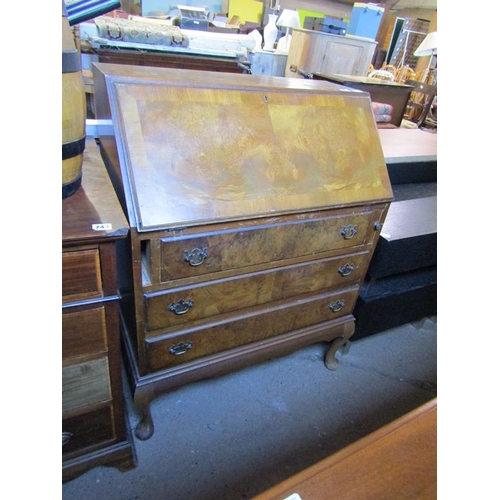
145,251,370,331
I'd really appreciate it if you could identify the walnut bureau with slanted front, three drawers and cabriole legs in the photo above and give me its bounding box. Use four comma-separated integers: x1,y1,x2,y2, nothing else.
94,63,392,439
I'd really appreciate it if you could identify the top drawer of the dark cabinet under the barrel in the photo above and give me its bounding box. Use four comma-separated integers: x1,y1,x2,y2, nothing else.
62,249,103,302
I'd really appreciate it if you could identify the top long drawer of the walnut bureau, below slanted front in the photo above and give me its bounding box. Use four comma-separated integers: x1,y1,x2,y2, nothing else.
160,211,375,282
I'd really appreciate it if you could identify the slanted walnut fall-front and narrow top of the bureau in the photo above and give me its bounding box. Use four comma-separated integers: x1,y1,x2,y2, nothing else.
96,65,392,231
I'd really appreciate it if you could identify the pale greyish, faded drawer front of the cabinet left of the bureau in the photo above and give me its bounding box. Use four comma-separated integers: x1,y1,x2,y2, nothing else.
62,357,111,414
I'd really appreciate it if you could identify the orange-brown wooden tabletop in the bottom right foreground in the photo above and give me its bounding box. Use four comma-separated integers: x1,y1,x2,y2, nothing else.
254,399,437,500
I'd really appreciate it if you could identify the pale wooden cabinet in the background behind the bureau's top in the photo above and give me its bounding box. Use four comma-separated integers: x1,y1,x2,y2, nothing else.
285,29,377,78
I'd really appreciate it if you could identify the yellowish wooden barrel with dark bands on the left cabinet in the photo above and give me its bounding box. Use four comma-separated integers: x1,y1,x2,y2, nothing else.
62,0,87,199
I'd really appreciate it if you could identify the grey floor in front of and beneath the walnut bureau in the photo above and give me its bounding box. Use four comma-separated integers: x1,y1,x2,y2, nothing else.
62,317,437,500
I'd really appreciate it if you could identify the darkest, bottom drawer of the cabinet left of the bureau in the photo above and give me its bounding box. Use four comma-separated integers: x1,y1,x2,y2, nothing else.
62,405,115,459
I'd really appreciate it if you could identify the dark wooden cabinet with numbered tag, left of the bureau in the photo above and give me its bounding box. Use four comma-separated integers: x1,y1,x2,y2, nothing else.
62,139,135,480
